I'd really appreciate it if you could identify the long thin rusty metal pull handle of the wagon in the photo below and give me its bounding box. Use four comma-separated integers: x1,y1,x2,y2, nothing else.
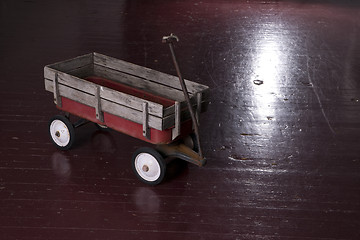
162,33,203,158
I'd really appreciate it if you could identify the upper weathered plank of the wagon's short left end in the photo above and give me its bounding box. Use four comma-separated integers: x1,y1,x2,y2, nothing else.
46,53,94,73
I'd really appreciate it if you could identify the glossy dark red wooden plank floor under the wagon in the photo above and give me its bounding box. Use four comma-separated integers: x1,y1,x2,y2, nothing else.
0,0,360,240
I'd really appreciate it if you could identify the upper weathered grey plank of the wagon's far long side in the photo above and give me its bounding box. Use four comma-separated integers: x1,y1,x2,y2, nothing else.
94,53,208,94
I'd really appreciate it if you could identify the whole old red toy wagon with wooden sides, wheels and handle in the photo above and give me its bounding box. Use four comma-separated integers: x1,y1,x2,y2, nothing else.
44,35,209,185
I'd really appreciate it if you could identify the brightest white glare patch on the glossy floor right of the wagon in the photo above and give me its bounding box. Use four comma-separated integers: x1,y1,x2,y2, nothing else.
249,23,290,124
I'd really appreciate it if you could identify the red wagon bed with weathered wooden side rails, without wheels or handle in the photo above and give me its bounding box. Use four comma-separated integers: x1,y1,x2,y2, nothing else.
44,53,209,144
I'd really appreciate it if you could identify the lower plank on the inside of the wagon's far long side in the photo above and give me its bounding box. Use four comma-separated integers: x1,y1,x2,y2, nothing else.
94,65,184,102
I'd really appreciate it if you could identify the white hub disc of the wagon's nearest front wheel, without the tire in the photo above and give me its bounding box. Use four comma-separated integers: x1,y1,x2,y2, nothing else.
135,153,161,182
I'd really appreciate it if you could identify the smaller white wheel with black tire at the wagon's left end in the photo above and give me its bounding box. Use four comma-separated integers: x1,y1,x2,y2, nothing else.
49,115,75,150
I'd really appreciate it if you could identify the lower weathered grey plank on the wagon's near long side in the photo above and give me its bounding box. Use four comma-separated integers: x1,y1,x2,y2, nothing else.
45,79,164,130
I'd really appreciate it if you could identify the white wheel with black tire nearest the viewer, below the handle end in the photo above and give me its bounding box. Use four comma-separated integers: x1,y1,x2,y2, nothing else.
132,147,166,185
